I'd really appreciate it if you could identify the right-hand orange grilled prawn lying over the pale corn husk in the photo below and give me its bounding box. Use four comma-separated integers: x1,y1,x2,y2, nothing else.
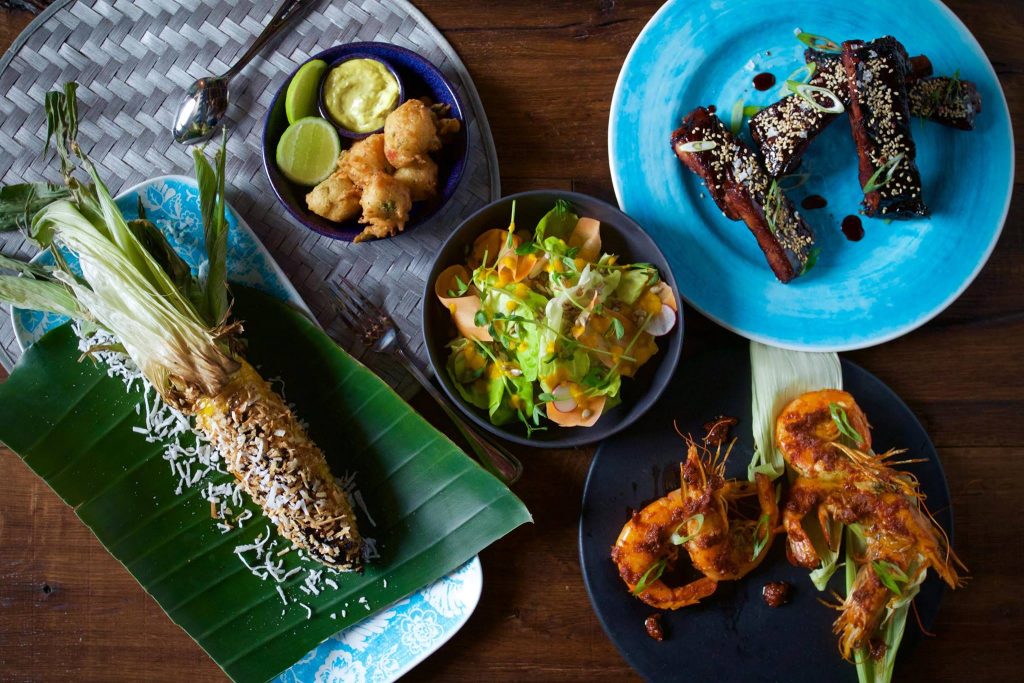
775,390,963,658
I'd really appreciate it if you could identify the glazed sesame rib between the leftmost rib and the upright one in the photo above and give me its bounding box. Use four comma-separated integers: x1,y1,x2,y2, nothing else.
750,49,932,177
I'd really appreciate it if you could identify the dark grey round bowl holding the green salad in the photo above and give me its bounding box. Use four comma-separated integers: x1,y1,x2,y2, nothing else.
423,190,683,449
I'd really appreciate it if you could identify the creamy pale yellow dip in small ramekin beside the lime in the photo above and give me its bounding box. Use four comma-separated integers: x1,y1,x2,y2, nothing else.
324,59,398,133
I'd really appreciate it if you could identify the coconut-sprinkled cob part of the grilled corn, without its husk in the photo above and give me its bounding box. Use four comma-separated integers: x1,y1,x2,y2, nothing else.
196,361,362,571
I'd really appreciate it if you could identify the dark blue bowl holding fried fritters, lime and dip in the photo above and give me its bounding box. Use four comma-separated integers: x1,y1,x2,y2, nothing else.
263,43,469,242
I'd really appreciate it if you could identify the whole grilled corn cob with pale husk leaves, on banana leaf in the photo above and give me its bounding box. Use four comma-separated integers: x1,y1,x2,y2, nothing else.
0,83,362,571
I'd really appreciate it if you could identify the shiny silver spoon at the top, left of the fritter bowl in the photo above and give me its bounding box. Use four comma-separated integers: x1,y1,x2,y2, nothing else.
171,0,315,144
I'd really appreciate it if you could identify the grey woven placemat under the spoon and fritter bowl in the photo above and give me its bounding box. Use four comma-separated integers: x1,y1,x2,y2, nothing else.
0,0,501,392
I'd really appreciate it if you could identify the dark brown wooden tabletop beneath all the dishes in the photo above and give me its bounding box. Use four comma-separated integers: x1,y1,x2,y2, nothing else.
0,0,1024,681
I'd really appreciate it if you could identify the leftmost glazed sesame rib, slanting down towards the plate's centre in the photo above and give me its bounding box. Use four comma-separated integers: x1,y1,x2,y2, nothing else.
672,106,814,283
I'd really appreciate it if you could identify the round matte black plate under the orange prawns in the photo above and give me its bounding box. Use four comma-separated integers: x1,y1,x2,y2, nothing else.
580,345,952,683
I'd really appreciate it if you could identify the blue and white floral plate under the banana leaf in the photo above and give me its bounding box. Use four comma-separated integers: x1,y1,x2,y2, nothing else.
11,175,483,683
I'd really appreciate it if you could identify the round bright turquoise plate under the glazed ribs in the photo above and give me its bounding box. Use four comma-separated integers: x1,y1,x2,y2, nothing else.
608,0,1014,350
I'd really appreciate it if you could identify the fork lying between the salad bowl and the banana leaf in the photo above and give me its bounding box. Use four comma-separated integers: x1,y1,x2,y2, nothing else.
328,278,522,484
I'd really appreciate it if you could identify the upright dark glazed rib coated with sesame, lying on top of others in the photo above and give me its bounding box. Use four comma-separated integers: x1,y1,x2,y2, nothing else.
843,36,928,218
